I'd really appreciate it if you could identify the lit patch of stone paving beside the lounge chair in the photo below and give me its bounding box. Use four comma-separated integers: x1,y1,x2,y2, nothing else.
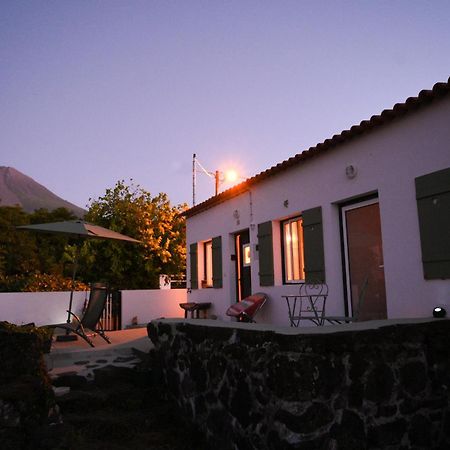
45,328,153,380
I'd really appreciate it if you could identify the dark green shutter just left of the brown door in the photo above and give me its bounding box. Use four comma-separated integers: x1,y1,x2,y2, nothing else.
302,206,325,282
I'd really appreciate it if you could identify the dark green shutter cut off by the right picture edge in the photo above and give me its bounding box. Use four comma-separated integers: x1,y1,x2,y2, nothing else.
415,168,450,280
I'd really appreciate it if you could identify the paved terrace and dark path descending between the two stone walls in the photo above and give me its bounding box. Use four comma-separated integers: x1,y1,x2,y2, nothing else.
40,327,208,450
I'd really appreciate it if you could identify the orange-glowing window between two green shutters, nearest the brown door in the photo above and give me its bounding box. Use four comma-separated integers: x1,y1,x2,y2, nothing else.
282,217,305,283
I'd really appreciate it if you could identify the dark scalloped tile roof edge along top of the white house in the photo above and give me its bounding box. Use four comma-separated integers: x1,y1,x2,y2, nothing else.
184,77,450,217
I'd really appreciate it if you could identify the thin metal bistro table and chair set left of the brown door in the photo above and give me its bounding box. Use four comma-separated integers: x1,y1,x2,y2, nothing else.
282,283,328,327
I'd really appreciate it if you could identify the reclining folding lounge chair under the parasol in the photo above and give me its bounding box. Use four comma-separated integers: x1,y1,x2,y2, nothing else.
44,283,111,347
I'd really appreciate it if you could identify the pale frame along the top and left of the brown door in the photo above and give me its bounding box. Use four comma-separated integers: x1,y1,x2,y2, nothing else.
339,195,384,316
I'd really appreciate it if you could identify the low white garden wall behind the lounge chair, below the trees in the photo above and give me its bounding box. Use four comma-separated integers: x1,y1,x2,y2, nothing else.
0,289,187,328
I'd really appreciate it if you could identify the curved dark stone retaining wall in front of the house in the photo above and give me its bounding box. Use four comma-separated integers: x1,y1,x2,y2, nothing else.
148,320,450,450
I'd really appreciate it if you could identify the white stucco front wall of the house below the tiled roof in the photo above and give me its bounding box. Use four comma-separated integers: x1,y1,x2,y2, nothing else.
187,97,450,325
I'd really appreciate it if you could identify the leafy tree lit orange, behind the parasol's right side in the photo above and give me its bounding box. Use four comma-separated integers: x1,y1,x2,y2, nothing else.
80,180,186,289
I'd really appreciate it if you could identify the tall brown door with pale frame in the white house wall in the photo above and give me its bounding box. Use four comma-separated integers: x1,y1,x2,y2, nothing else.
342,200,387,320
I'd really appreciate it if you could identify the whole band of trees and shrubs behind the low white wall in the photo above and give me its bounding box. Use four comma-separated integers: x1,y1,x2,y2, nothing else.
0,181,186,291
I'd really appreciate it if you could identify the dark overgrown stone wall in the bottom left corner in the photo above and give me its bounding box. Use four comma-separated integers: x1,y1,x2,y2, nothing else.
0,322,60,449
